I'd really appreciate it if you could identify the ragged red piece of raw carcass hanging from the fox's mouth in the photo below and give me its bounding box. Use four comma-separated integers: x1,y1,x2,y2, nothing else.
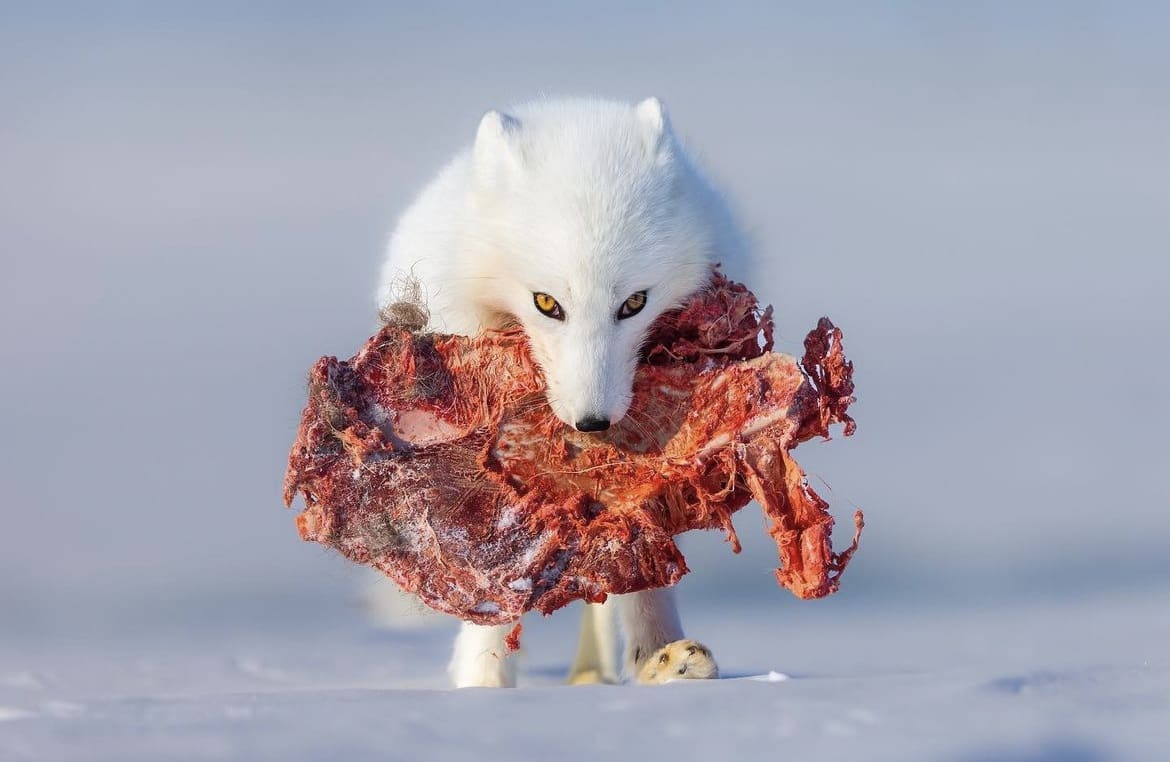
284,273,862,624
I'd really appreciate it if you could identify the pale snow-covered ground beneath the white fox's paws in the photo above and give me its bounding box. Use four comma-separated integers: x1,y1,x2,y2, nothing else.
0,591,1170,762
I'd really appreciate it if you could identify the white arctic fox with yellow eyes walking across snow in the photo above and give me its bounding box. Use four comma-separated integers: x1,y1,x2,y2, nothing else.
378,93,744,687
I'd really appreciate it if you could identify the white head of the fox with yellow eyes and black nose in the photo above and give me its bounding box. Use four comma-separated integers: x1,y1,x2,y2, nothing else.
463,98,738,431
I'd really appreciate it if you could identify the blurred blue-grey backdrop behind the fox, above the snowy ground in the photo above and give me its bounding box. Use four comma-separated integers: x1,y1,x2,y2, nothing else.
0,2,1170,655
